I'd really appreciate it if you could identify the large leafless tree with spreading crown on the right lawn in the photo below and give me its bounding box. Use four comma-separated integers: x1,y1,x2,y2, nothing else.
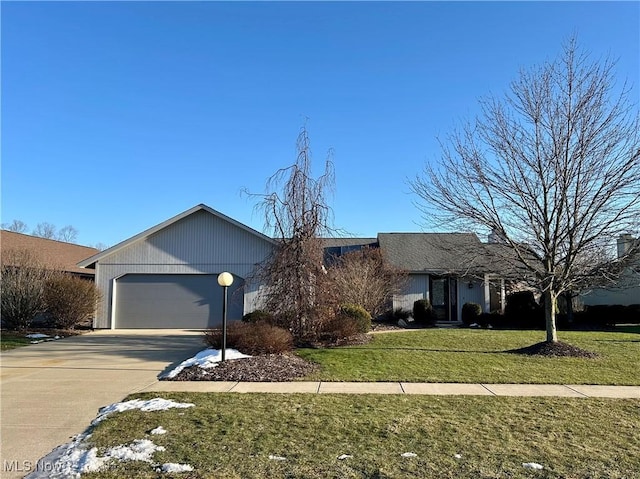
411,38,640,342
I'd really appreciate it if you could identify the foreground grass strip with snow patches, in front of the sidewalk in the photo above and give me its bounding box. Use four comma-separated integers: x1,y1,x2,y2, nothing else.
83,393,640,479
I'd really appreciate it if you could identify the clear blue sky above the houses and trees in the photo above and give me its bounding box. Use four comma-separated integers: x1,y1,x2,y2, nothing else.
0,1,640,249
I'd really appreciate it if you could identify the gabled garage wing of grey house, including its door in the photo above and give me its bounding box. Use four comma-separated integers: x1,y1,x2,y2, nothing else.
79,205,276,329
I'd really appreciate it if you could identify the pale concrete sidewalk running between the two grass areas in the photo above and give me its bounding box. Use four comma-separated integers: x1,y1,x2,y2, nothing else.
140,381,640,399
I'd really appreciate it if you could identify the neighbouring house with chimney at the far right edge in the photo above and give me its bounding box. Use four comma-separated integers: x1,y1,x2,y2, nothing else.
580,234,640,306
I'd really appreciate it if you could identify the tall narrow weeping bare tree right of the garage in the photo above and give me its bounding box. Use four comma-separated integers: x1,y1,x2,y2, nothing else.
250,127,334,339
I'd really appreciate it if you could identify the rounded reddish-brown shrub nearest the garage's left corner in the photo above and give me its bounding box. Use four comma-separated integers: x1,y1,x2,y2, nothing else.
44,273,100,329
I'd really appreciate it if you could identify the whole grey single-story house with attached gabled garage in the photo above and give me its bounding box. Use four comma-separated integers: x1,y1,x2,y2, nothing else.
79,204,504,329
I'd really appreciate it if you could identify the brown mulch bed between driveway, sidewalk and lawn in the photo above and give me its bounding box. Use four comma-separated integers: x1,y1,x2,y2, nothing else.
165,354,319,382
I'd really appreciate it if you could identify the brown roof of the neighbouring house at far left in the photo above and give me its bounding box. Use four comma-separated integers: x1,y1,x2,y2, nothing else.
0,230,99,275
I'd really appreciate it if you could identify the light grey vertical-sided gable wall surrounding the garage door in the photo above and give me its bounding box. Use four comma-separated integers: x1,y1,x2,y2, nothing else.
94,211,273,328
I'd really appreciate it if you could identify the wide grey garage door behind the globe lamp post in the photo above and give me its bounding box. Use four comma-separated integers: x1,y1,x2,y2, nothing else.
115,274,243,329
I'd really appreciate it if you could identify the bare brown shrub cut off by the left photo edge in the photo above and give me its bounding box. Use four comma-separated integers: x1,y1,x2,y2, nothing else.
0,250,53,330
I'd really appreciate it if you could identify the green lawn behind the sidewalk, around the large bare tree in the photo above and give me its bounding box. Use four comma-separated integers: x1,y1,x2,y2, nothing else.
297,329,640,385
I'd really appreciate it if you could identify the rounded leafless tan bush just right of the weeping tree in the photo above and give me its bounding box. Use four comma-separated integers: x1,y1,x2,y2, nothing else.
329,248,407,317
